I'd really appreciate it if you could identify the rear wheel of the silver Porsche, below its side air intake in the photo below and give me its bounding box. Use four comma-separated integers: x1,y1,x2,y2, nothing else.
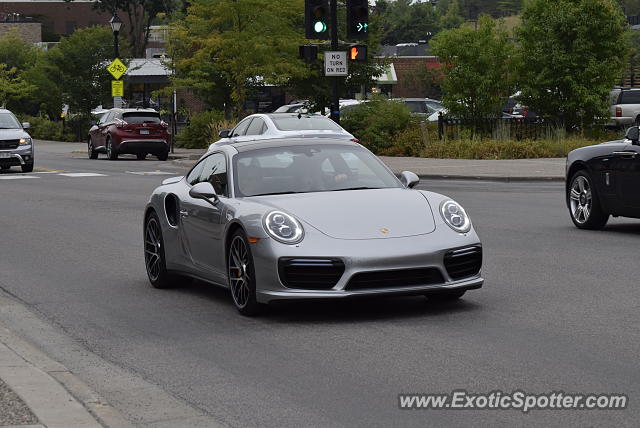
144,212,176,288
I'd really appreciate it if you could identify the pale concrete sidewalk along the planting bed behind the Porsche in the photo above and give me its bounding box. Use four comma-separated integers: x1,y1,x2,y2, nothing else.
170,148,566,181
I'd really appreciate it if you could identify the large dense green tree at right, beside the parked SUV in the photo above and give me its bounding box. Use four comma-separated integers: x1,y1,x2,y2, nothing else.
517,0,629,130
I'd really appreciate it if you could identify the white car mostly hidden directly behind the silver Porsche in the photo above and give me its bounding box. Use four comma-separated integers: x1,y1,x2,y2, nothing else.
209,113,357,149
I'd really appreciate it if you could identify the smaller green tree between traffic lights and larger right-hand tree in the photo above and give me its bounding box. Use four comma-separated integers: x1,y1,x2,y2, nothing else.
432,15,515,124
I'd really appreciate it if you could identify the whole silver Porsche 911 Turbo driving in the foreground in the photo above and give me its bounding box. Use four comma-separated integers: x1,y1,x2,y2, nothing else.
144,138,483,315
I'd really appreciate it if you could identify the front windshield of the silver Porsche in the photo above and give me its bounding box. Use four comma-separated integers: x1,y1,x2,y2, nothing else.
233,144,401,197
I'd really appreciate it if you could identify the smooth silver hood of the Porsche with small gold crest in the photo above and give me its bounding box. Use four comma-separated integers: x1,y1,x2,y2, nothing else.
260,188,435,239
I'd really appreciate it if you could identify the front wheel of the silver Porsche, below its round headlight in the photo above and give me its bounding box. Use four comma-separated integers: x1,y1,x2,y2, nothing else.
227,229,263,316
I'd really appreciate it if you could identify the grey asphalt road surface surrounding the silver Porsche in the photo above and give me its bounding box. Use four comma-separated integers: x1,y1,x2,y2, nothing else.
0,144,640,427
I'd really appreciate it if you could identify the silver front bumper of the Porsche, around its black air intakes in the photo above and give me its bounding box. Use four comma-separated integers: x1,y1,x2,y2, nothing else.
251,225,484,303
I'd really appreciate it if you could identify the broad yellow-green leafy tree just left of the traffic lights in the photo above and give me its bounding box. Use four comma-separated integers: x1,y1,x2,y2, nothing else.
170,0,308,115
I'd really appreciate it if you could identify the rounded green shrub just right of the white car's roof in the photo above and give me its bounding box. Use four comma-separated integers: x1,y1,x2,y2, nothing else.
340,99,412,153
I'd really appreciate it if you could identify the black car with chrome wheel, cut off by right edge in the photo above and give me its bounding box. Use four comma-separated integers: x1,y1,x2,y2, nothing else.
566,126,640,229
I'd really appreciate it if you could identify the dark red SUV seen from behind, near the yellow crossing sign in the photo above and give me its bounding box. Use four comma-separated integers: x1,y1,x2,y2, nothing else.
87,108,169,161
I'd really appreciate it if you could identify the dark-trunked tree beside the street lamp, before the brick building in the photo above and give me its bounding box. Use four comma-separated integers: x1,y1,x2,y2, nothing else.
65,0,182,58
